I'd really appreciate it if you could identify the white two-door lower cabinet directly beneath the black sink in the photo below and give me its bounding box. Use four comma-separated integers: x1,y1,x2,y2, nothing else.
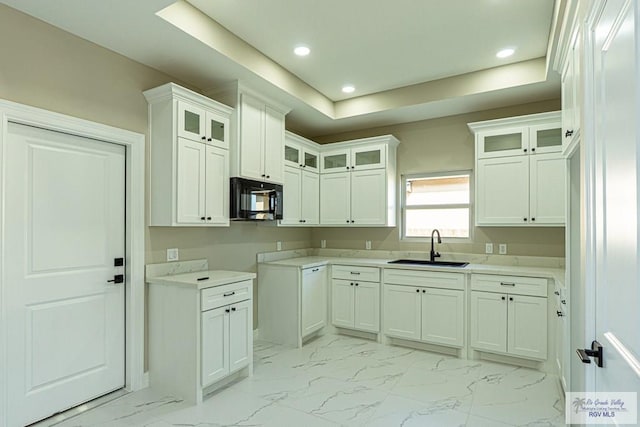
384,270,465,348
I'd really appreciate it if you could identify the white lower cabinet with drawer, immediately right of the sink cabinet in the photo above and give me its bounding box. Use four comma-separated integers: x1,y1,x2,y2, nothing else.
470,274,548,360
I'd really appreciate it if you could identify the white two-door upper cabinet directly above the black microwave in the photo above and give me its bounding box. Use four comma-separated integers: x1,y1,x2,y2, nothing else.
209,82,290,184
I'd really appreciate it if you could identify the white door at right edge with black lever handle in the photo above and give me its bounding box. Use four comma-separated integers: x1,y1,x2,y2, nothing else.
585,0,640,412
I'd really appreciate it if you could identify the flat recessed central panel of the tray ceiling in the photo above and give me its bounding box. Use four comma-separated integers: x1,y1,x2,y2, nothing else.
189,0,553,101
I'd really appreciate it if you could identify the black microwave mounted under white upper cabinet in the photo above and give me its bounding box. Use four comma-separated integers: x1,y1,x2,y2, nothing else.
230,177,282,221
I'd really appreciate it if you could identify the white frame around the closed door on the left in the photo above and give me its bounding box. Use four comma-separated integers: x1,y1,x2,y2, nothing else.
0,99,147,427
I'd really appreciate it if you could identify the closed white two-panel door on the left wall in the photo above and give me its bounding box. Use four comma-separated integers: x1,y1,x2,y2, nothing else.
2,123,125,426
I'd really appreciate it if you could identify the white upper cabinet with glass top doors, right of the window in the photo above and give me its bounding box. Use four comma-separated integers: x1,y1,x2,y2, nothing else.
469,112,566,226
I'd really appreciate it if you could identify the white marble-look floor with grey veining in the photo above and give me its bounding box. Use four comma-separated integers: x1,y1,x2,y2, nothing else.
40,335,565,427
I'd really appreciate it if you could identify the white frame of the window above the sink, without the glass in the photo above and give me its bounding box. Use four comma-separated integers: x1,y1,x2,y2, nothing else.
398,169,475,243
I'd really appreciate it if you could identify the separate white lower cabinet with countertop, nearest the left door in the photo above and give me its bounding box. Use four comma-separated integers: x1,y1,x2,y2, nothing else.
149,271,255,403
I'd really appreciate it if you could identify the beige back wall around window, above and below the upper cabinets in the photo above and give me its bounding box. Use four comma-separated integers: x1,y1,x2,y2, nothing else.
312,99,564,257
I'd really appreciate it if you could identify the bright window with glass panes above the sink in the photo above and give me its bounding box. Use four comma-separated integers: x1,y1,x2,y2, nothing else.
402,171,471,238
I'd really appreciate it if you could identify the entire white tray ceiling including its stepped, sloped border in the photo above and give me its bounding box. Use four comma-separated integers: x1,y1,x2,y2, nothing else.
0,0,560,137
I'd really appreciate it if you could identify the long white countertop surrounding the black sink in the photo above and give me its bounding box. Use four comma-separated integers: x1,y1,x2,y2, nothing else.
262,256,564,284
